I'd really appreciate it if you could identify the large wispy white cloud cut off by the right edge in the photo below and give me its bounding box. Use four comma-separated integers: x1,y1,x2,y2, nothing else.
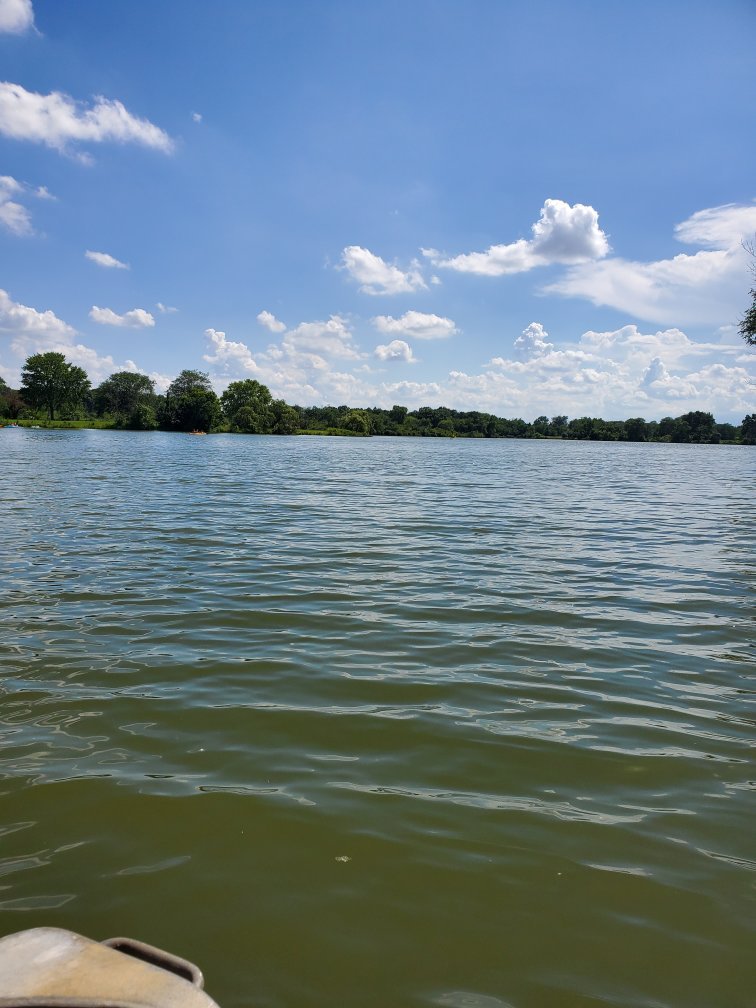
544,204,756,327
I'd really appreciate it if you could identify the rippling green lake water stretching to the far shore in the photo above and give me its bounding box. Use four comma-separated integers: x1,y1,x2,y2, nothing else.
0,430,756,1008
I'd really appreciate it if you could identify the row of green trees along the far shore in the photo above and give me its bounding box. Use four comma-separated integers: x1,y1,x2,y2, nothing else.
0,353,756,445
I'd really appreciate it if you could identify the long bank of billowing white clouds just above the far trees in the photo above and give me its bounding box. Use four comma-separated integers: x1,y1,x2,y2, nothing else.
192,304,756,422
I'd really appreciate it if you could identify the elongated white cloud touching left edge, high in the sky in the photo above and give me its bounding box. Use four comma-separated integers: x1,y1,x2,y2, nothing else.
0,82,173,153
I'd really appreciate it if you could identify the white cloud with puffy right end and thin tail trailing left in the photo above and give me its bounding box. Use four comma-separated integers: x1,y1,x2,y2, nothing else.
422,200,609,276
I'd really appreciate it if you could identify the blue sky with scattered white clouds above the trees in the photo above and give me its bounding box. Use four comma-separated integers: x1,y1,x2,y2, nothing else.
0,0,756,421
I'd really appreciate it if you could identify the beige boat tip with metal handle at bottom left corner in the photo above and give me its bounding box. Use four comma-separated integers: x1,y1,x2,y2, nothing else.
0,927,218,1008
